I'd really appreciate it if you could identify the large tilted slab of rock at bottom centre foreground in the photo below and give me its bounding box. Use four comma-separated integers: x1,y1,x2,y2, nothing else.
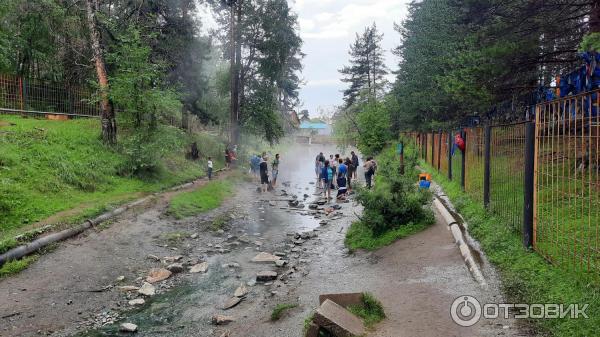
313,299,365,337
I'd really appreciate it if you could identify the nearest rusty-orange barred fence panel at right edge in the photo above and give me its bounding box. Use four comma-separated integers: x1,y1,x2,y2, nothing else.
534,91,600,270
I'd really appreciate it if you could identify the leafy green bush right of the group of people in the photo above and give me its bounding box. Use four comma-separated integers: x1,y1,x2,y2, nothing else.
356,147,433,237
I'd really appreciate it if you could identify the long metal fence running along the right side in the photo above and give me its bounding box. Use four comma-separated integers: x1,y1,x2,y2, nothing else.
409,90,600,272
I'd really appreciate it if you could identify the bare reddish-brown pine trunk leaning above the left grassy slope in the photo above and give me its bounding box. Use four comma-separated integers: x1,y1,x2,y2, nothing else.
85,0,117,144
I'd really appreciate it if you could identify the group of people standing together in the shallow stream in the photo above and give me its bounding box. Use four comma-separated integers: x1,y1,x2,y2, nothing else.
315,151,377,200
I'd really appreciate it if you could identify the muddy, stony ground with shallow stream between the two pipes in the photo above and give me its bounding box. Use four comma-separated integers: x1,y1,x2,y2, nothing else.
0,145,528,337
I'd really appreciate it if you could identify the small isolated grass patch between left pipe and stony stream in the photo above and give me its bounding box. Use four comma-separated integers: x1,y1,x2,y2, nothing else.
167,180,233,219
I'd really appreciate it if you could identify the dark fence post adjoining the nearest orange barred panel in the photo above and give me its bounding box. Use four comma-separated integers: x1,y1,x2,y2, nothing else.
523,122,535,248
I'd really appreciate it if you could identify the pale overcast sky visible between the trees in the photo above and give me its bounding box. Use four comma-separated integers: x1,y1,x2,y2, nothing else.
201,0,410,117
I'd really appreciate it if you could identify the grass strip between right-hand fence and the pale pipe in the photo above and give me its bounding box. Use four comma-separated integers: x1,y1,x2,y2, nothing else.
423,164,600,337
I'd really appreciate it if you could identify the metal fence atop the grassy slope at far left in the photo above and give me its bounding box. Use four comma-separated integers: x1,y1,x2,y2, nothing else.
0,74,100,117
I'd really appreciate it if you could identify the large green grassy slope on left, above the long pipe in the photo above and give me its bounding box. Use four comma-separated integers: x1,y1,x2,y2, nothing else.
0,115,220,241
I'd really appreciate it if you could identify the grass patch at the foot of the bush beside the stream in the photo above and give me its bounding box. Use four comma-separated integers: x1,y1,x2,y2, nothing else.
344,221,431,251
